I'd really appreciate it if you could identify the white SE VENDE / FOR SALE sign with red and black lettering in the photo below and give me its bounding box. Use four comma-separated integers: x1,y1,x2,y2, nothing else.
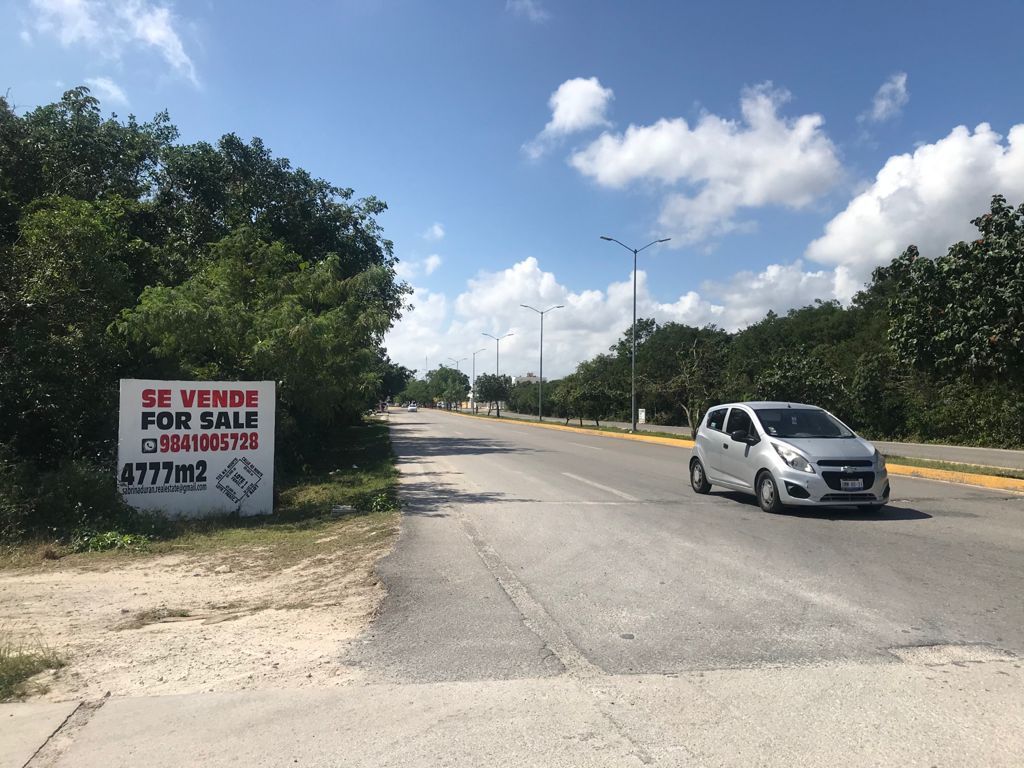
118,379,275,517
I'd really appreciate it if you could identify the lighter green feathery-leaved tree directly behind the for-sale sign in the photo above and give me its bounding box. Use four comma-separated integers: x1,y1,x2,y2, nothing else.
116,229,404,468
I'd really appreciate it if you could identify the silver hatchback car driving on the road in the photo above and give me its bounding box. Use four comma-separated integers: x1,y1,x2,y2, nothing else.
690,402,889,512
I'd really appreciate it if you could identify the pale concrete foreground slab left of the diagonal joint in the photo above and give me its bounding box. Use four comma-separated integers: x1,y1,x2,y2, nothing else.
51,679,642,768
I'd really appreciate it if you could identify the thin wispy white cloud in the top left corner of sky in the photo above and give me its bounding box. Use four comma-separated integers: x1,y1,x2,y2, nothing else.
31,0,199,85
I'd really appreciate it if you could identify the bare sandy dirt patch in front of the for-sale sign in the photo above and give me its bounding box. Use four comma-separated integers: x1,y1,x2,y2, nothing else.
0,529,393,700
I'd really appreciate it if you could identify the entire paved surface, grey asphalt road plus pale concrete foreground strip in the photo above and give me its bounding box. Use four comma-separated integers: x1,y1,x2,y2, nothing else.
16,411,1024,768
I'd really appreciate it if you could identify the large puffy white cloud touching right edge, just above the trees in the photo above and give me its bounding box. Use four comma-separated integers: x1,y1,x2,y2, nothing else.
806,123,1024,299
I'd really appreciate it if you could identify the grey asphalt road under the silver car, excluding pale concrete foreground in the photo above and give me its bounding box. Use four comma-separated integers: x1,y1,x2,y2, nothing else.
352,411,1024,681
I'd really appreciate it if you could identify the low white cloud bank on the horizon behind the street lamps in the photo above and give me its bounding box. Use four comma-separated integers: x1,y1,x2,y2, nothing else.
386,258,833,377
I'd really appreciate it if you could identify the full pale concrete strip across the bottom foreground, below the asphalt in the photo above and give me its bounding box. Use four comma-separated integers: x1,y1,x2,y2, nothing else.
44,659,1024,768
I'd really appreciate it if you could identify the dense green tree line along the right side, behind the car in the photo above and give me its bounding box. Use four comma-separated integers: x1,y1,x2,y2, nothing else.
544,196,1024,447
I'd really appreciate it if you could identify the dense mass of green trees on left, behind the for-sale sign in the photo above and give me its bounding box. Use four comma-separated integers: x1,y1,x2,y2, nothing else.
0,88,411,539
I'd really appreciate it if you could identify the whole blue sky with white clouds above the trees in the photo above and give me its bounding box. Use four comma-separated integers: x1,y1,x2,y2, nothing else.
6,0,1024,377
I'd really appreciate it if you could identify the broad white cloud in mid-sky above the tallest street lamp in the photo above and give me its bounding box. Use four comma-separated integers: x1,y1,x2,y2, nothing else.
569,83,843,245
